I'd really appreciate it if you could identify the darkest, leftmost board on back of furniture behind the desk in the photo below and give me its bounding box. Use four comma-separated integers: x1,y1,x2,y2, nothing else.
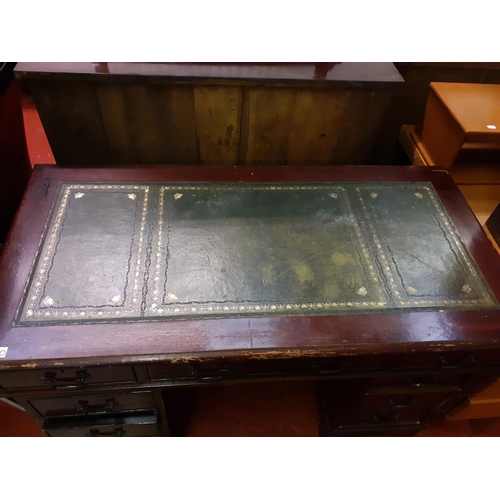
30,80,112,165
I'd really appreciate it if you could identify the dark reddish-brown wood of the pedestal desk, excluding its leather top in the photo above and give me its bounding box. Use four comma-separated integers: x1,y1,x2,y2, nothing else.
0,166,500,436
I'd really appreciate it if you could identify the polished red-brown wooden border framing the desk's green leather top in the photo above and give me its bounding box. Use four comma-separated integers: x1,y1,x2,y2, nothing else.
0,166,500,368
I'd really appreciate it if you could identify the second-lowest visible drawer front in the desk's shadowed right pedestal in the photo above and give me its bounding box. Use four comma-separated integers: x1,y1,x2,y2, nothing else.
353,392,452,410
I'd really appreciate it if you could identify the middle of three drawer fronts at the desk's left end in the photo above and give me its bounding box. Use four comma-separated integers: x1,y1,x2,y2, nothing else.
30,391,155,416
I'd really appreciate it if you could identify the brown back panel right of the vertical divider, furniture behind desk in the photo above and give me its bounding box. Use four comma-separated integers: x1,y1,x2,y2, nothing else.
240,88,391,165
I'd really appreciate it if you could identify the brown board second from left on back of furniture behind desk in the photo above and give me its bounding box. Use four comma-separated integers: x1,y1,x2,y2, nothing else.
96,83,197,164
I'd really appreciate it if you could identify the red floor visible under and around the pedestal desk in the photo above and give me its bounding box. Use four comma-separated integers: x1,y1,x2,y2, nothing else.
0,94,500,437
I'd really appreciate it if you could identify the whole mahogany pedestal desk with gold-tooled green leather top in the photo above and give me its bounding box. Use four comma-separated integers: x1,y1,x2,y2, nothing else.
0,165,500,437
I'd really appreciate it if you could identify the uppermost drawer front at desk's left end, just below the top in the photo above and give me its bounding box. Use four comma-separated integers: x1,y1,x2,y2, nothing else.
0,366,136,389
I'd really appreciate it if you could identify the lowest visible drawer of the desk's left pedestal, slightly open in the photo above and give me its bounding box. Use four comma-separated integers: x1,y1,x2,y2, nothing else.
43,412,160,437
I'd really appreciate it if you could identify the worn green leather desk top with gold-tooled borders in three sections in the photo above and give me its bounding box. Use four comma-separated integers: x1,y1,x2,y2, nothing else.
17,183,498,324
